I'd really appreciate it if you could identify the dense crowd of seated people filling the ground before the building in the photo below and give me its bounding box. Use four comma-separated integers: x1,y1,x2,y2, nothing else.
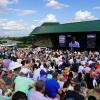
0,47,100,100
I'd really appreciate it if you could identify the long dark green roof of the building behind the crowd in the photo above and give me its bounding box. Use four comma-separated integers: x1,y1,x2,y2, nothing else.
31,20,100,35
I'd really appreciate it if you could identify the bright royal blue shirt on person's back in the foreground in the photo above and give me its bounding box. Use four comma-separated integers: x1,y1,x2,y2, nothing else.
45,79,60,98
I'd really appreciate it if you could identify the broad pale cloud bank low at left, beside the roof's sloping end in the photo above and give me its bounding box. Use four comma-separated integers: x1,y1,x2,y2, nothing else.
0,19,35,37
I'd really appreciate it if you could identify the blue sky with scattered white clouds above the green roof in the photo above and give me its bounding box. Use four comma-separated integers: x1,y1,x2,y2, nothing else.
0,0,100,37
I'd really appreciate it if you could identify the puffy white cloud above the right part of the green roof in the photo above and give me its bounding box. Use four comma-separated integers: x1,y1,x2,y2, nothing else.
73,10,98,22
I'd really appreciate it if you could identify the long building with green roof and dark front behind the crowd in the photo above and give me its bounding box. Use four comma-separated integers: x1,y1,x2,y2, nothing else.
31,20,100,49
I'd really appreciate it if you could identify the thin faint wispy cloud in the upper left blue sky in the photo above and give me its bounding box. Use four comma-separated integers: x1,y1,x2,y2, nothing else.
8,8,37,16
